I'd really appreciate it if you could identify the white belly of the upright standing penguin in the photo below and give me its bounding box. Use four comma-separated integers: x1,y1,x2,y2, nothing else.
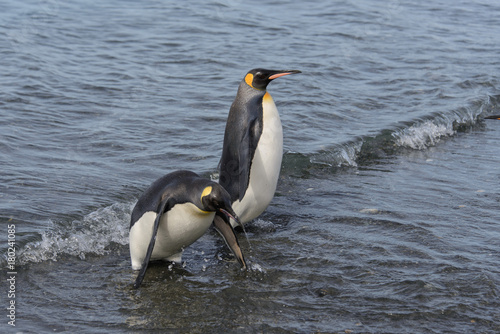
231,93,283,227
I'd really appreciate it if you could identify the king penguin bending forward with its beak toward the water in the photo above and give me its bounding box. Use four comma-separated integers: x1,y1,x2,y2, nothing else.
129,171,246,288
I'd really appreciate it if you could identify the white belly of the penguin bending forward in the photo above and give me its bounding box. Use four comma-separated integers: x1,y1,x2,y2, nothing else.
129,203,215,269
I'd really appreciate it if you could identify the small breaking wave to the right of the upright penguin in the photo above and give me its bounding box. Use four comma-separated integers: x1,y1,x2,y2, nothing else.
292,95,500,171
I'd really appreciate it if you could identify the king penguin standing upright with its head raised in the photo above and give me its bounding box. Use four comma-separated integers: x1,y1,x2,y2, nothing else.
214,68,301,227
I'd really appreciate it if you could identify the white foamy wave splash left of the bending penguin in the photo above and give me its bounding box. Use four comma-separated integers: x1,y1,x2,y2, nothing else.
18,203,133,265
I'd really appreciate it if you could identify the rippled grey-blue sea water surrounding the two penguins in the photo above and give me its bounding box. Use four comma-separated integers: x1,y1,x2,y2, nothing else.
0,0,500,333
